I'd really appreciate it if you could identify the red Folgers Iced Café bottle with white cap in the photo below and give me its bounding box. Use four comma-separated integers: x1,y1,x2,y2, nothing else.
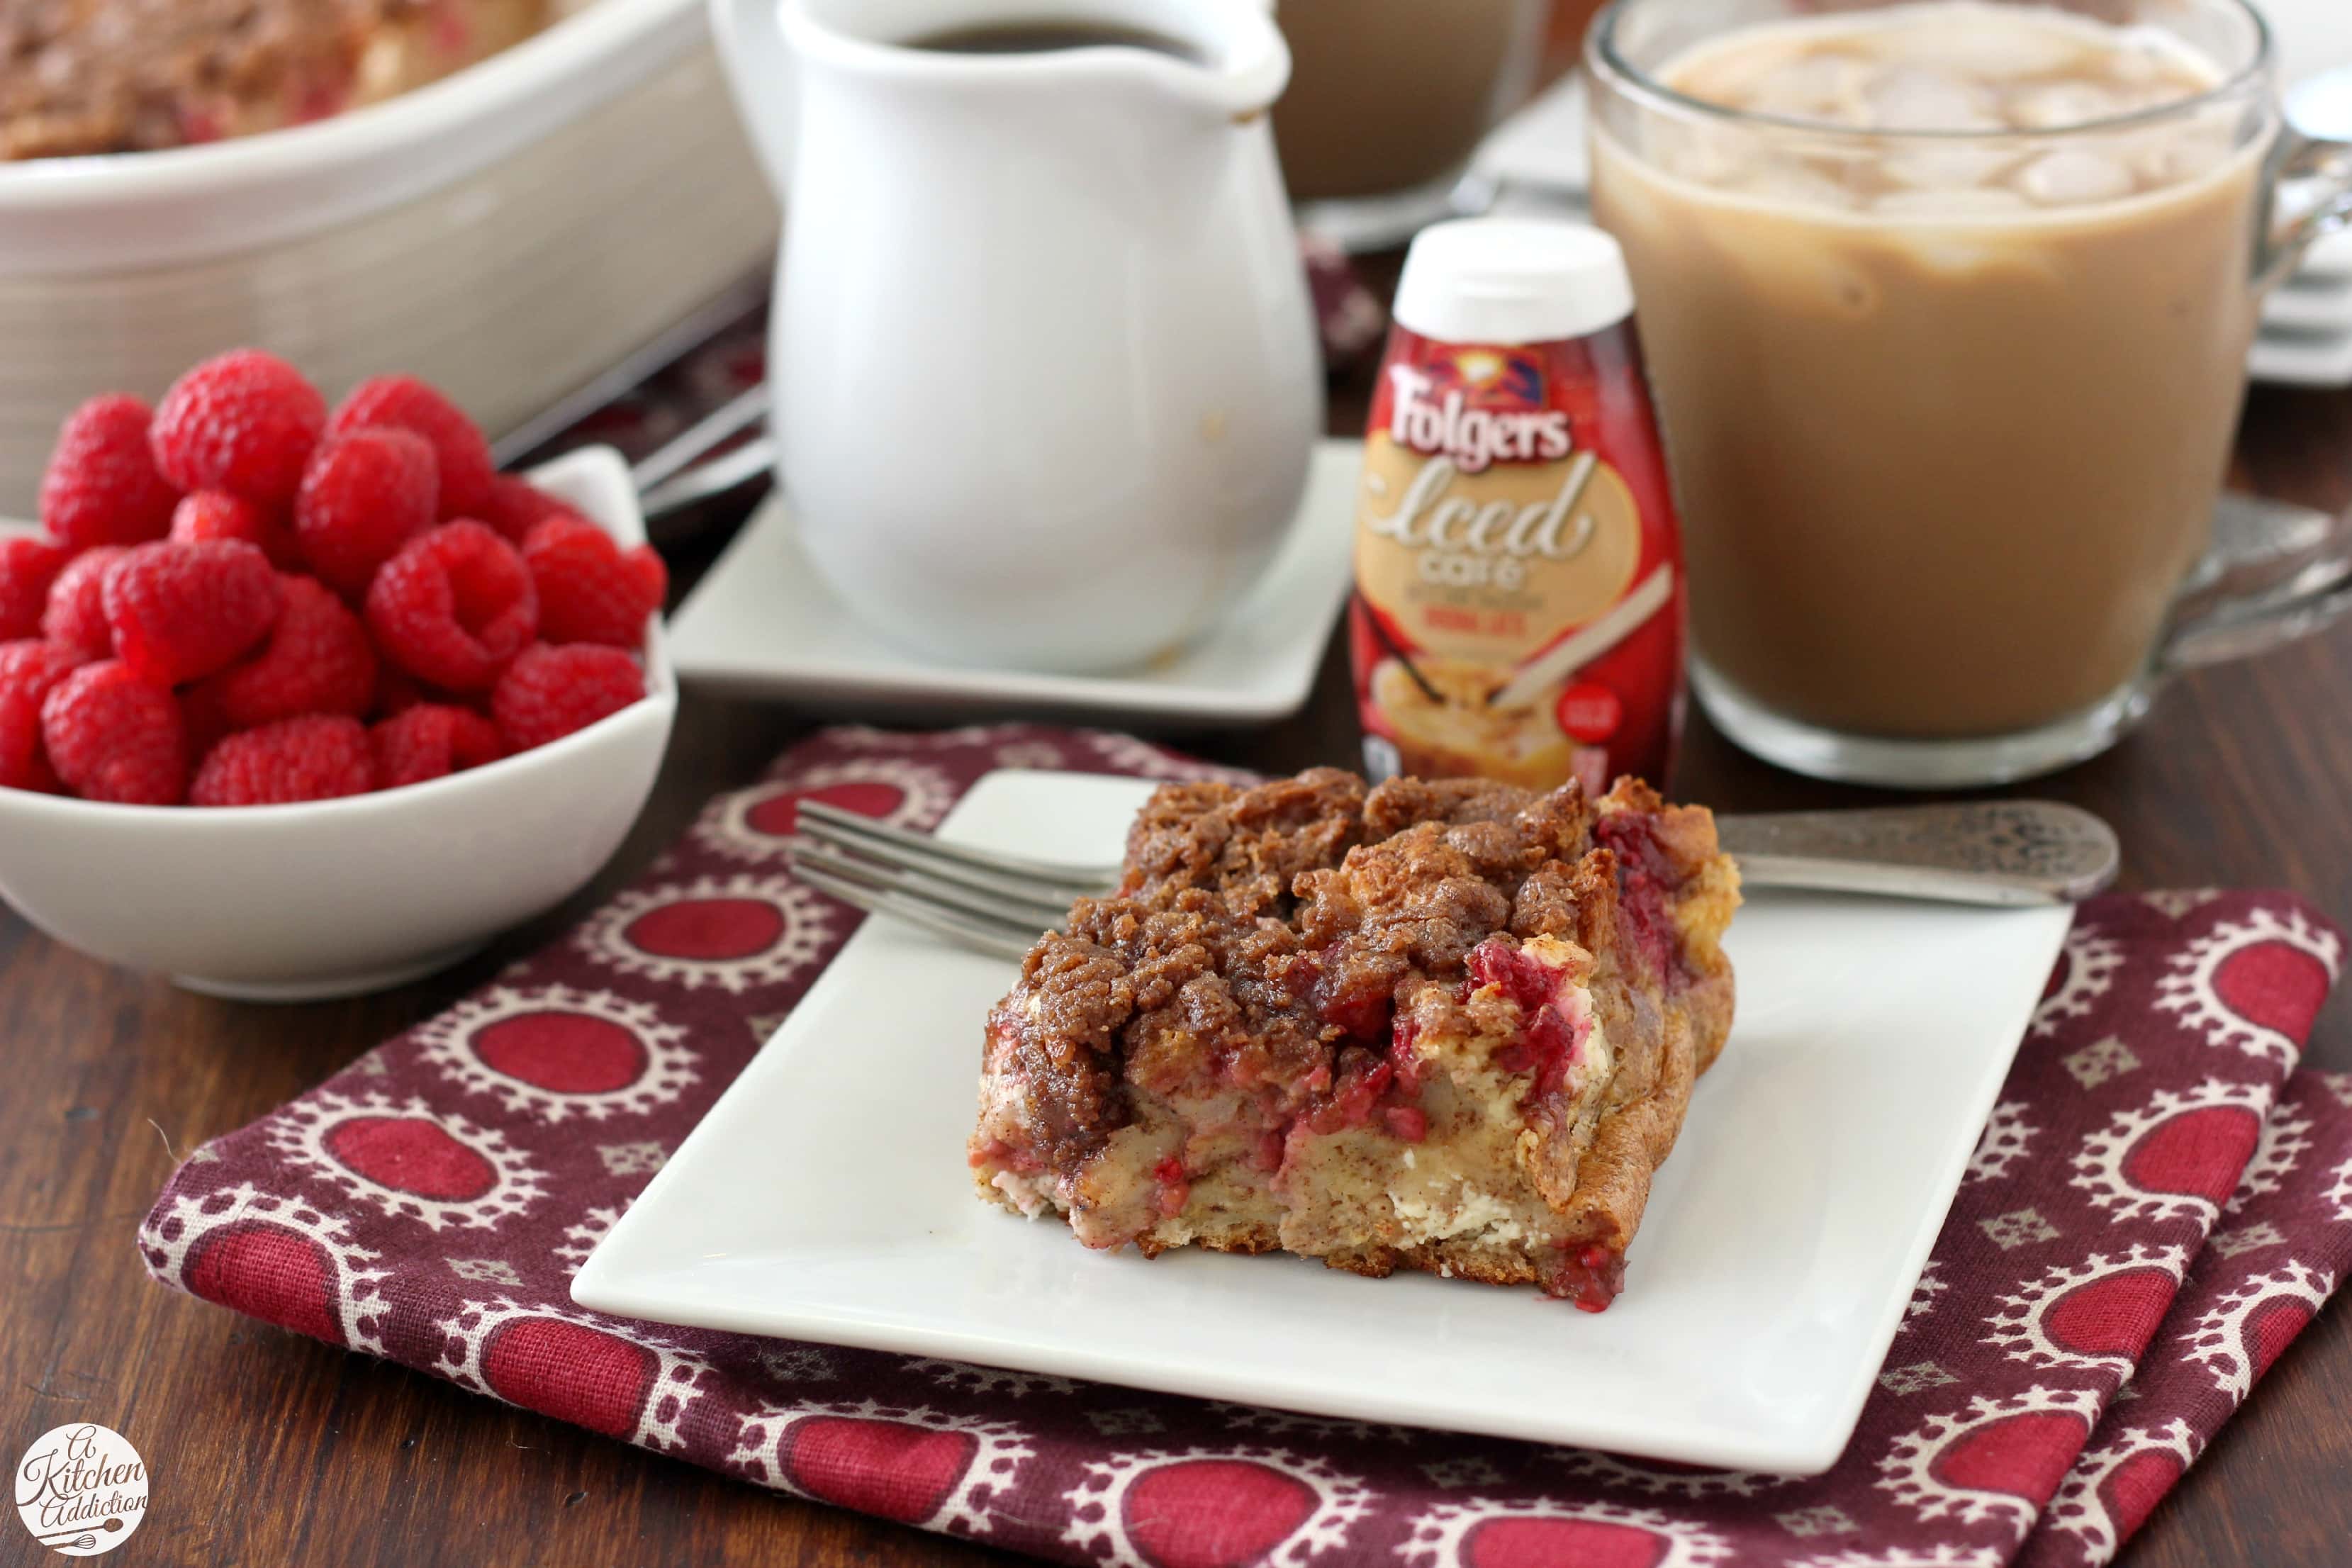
1350,218,1684,793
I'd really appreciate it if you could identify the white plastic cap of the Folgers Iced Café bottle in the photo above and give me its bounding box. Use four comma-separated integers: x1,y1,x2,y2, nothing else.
1395,218,1633,343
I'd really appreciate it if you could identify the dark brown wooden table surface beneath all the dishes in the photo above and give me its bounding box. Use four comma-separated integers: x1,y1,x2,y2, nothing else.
0,350,2352,1568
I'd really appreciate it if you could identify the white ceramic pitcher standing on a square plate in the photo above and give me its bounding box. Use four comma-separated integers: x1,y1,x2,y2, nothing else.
712,0,1322,670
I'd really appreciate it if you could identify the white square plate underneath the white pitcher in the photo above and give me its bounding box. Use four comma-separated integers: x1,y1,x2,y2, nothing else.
671,439,1364,729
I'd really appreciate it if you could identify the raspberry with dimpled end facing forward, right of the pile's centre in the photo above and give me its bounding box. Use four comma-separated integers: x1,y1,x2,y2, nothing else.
367,520,539,691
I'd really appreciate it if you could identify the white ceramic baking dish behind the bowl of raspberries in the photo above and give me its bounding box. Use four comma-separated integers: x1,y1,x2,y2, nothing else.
0,0,776,515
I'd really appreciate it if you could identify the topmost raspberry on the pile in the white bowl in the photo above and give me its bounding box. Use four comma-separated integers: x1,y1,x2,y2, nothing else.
148,348,327,508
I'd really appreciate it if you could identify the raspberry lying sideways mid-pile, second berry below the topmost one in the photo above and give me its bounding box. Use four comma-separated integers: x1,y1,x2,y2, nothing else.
106,538,278,686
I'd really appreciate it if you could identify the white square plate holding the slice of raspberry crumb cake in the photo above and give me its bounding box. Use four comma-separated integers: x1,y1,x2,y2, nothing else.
571,771,2068,1474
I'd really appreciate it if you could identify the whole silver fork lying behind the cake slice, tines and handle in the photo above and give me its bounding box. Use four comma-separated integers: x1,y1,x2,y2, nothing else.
790,800,2122,959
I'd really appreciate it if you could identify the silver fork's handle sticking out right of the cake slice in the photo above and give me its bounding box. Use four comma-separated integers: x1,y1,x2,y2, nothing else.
1715,800,2122,905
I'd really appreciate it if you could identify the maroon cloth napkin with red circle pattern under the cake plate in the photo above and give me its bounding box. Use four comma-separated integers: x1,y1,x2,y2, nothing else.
139,727,2352,1568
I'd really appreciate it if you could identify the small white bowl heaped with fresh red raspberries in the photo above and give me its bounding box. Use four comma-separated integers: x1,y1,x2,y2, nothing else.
0,355,678,1002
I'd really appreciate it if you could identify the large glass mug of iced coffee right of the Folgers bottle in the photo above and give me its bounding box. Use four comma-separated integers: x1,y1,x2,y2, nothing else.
1585,0,2347,785
